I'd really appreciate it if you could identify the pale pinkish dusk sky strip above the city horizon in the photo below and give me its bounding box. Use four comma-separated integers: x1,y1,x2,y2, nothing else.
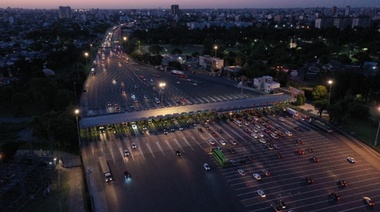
0,0,380,9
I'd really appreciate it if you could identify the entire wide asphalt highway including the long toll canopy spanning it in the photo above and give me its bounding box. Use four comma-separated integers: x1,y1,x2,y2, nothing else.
80,26,380,212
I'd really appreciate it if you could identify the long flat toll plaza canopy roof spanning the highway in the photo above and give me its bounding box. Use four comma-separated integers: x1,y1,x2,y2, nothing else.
79,94,293,128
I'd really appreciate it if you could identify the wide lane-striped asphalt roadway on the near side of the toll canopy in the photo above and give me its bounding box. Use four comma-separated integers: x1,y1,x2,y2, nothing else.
83,112,380,211
